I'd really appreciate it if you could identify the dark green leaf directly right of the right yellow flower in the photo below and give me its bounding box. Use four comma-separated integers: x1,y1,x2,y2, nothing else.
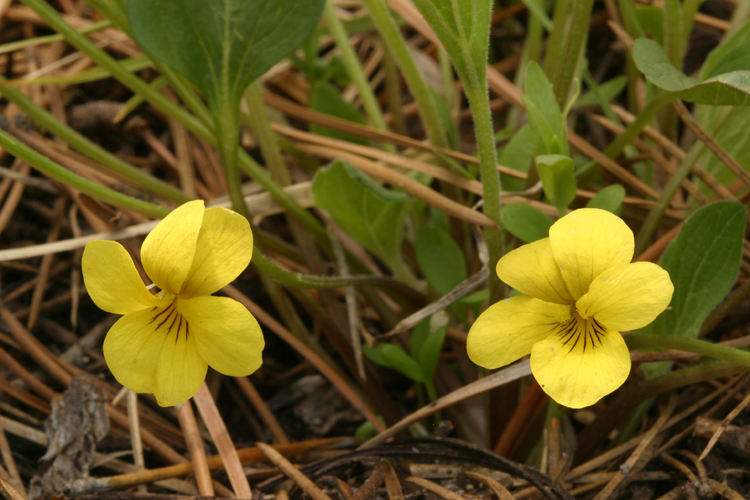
637,201,747,338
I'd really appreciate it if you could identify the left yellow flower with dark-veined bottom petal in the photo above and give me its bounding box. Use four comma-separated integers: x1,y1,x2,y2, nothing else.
81,200,264,406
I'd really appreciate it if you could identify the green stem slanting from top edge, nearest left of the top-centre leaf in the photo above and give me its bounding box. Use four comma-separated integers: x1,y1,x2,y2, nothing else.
362,0,448,147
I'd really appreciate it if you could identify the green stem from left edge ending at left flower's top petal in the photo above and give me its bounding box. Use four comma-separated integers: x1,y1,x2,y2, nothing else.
0,126,170,219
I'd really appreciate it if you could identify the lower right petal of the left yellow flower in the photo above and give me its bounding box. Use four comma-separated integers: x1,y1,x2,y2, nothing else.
178,296,265,377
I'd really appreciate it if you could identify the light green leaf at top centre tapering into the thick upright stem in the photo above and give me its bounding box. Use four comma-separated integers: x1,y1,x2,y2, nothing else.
414,0,493,88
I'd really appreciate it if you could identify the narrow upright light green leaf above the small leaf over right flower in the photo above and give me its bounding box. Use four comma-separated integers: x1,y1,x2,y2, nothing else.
523,61,568,156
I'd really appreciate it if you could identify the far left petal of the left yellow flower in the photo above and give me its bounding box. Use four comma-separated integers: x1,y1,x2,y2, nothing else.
81,240,161,314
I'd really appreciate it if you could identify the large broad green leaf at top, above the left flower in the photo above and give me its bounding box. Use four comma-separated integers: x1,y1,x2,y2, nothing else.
127,0,325,107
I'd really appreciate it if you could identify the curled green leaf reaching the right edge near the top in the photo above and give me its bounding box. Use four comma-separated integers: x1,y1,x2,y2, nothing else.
633,38,750,106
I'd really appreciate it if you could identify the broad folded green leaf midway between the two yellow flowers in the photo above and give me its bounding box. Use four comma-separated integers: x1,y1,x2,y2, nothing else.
312,161,411,265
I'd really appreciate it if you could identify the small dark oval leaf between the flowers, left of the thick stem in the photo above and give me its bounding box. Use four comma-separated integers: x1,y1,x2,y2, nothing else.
414,226,466,295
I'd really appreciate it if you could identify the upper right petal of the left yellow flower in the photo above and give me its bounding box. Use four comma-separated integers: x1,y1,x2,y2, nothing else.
181,207,253,297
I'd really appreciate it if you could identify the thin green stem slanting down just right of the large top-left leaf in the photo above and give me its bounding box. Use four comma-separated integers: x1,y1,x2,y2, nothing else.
324,0,396,153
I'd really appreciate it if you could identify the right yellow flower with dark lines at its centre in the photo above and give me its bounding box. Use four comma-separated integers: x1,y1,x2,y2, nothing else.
466,208,674,408
